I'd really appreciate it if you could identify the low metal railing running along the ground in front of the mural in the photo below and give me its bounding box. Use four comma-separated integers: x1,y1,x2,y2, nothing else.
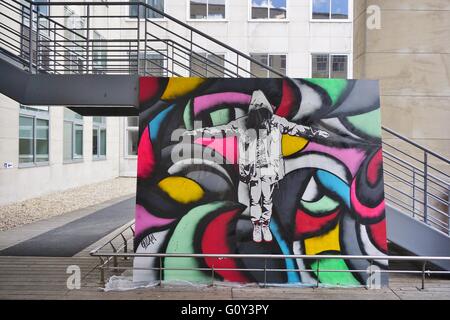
90,221,450,289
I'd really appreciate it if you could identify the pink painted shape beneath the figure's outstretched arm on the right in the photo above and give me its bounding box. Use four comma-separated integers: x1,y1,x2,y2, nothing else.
304,142,366,177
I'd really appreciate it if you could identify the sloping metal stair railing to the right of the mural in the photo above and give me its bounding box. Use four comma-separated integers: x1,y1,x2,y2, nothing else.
383,127,450,236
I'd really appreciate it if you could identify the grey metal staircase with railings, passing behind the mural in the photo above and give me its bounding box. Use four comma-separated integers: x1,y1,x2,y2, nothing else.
0,0,450,270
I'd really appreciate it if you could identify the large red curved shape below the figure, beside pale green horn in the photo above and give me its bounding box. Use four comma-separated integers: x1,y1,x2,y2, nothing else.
201,209,249,282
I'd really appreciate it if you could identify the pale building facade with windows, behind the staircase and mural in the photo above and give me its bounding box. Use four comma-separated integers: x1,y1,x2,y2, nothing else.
0,0,353,205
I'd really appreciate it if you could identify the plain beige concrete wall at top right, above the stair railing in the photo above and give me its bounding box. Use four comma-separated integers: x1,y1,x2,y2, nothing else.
354,0,450,157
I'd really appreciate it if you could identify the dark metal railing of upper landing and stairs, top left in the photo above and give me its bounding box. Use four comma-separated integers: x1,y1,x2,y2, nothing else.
0,0,284,77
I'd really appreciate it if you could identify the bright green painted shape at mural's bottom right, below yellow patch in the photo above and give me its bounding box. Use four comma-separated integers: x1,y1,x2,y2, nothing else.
311,259,361,286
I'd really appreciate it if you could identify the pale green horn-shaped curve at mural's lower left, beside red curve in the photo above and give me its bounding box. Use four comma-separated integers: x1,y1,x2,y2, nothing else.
164,201,228,283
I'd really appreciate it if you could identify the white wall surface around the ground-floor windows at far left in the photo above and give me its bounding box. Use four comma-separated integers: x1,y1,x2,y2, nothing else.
0,95,120,205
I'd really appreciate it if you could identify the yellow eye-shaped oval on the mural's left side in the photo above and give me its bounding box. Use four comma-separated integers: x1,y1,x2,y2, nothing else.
158,177,205,203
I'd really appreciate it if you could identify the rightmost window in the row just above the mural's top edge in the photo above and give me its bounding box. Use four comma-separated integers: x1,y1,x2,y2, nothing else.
311,54,348,79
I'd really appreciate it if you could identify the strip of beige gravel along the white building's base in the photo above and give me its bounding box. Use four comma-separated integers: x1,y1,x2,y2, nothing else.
0,178,136,231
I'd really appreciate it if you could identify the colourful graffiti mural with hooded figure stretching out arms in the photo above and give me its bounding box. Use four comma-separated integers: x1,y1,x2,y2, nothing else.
133,77,387,286
